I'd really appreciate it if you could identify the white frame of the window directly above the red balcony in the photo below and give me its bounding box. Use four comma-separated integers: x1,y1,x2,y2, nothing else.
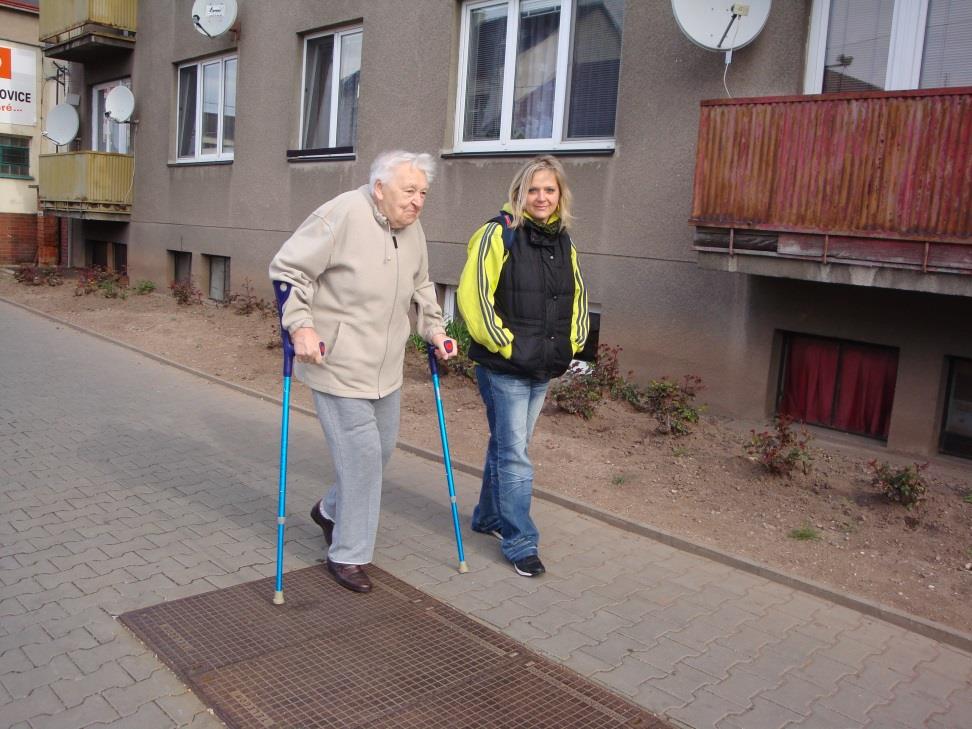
803,0,929,94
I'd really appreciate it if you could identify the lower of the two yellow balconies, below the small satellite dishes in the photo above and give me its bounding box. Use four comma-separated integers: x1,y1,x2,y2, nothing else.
39,152,135,222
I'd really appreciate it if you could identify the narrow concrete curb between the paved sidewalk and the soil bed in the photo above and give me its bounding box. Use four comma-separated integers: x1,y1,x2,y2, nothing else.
7,296,972,653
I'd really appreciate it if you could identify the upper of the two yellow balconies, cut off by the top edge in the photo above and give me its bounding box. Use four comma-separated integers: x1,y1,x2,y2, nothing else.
39,0,138,63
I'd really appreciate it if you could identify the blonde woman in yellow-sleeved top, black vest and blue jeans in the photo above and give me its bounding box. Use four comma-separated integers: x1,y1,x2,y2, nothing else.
458,156,588,577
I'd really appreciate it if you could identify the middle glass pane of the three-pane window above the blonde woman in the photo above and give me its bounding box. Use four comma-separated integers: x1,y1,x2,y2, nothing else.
511,0,560,139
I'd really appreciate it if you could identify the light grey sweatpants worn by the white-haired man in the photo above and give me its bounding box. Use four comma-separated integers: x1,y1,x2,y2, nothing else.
313,390,401,564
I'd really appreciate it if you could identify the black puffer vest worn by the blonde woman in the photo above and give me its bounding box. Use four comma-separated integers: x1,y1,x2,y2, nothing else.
469,219,574,380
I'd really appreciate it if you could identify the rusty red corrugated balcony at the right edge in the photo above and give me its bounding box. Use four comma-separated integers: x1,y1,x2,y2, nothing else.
689,87,972,296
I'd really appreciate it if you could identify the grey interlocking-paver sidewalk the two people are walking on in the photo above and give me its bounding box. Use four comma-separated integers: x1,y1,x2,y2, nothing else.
0,302,972,729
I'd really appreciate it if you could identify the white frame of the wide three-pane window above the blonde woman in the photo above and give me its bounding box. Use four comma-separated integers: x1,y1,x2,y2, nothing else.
453,0,621,152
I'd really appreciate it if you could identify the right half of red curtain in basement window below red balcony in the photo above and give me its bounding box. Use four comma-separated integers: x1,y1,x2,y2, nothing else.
833,344,898,438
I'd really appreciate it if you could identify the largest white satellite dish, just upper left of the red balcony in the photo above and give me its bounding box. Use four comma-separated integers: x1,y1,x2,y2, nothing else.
672,0,770,51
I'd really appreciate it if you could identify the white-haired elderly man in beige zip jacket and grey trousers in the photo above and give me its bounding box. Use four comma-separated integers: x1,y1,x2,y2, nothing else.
270,151,455,592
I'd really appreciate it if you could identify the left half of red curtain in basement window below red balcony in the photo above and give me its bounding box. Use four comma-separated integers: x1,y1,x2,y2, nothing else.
780,337,840,425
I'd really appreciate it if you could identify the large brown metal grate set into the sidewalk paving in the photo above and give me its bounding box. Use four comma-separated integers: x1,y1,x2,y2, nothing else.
121,567,669,729
